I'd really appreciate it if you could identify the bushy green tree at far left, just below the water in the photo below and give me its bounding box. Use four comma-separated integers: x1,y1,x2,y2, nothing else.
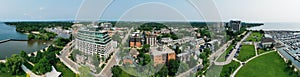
6,54,24,75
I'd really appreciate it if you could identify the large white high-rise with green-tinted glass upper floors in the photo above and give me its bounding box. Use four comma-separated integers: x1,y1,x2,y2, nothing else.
75,26,113,58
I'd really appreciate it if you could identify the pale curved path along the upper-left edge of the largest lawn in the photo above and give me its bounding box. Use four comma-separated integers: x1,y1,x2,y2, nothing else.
230,51,275,77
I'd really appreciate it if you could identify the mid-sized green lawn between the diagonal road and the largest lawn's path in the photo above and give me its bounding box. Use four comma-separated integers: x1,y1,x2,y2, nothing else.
237,45,255,61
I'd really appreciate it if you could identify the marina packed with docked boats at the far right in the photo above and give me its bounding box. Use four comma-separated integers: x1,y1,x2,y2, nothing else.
265,31,300,68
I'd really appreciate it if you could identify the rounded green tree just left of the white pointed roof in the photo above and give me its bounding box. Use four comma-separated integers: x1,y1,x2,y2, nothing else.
33,58,52,75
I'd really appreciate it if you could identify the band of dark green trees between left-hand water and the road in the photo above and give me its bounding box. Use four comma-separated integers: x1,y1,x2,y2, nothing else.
20,38,69,75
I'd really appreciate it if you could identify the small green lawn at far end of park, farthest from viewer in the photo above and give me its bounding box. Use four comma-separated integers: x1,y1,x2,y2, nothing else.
246,32,263,42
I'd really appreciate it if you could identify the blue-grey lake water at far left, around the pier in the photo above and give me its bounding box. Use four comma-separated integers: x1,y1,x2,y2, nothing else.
0,22,50,60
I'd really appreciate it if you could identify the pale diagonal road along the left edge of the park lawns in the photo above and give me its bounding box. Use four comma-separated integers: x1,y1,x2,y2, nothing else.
214,32,252,65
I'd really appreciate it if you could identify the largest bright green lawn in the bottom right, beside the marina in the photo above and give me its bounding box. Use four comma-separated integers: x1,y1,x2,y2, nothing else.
236,52,297,77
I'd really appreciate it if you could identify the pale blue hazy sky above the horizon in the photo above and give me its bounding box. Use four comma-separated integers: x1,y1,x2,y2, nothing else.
0,0,300,22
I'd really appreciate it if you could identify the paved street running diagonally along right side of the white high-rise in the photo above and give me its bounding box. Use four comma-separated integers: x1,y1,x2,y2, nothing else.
94,28,133,77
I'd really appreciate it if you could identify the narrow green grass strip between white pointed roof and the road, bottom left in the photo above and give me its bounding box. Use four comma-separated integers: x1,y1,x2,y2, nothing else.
55,61,76,77
